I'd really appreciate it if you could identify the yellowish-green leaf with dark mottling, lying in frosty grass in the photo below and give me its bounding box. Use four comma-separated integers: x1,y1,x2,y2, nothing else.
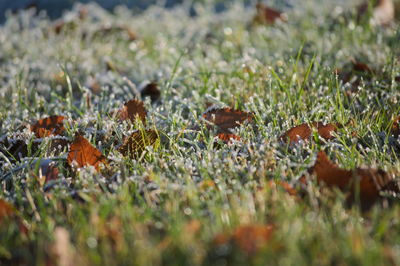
118,130,159,159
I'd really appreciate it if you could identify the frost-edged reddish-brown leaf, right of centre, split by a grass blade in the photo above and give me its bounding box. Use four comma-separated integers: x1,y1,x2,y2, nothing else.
279,122,340,144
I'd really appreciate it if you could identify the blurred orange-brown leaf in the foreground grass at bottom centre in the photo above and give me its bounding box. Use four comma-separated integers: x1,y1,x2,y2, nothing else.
213,224,275,255
